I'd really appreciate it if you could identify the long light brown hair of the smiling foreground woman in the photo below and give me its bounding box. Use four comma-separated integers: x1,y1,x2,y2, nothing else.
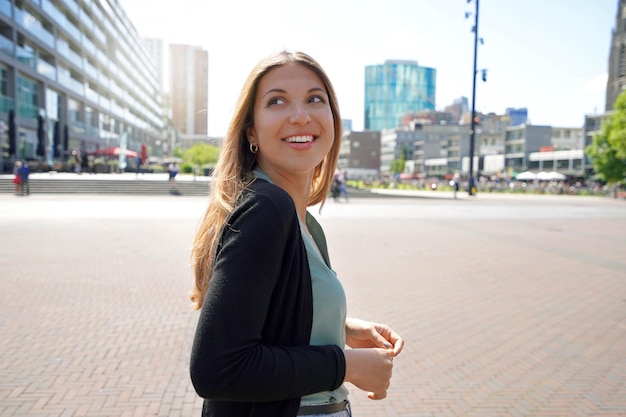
191,51,342,310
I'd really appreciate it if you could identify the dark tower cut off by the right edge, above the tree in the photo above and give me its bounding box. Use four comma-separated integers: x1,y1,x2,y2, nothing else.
606,0,626,111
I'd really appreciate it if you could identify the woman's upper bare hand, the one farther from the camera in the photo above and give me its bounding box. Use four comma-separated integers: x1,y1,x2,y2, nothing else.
346,318,404,357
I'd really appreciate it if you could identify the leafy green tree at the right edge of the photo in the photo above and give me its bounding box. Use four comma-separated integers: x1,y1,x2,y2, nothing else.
585,92,626,197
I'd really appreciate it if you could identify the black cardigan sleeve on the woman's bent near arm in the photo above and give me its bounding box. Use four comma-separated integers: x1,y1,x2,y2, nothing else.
190,187,345,402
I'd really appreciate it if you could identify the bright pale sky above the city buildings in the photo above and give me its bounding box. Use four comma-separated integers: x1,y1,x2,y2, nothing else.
119,0,618,136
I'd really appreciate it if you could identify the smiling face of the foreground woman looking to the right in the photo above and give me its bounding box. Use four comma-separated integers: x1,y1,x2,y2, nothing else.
247,63,335,182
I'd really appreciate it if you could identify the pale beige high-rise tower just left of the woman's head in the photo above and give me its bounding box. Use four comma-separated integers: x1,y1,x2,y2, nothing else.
169,45,209,137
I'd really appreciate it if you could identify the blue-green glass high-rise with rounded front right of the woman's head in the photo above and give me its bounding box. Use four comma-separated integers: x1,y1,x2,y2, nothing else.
363,60,437,130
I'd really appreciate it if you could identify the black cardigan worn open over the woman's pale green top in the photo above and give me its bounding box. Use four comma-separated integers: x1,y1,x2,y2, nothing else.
190,179,346,417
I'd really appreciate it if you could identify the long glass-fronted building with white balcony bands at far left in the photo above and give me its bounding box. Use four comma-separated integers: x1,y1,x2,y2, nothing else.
0,0,164,171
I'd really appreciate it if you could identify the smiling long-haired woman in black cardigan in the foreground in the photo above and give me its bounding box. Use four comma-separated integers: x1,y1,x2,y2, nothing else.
190,52,404,417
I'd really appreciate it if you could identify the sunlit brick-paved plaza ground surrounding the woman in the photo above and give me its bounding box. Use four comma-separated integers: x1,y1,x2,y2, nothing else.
0,195,626,417
